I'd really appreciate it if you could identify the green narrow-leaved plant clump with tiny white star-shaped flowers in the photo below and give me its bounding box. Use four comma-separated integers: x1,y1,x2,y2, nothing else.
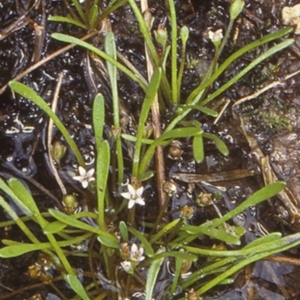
0,0,300,300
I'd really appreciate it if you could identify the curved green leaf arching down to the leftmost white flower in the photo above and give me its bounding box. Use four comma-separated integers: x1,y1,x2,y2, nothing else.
8,81,85,167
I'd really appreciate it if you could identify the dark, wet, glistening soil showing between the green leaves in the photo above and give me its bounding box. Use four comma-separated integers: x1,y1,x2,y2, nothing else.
0,0,300,300
